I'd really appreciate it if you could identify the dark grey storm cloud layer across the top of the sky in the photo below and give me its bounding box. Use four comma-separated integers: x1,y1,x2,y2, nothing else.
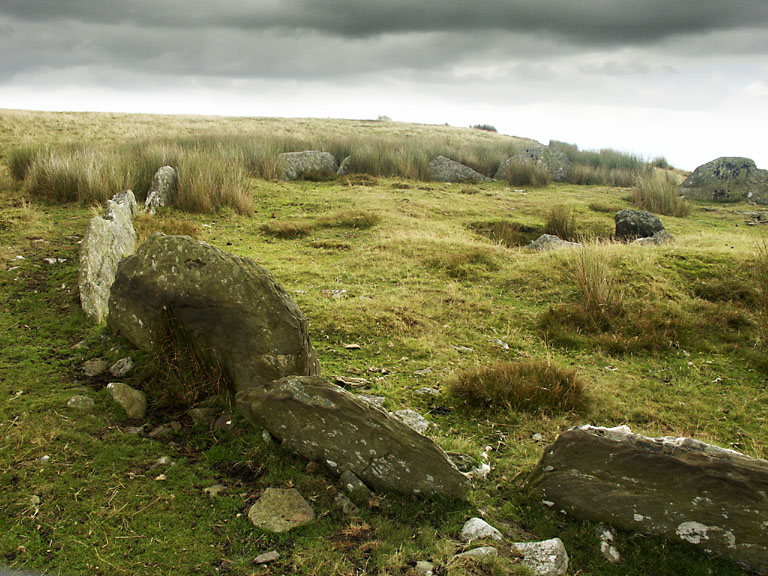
0,0,768,81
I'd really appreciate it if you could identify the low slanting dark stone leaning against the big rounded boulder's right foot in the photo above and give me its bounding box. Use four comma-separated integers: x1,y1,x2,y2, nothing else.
237,376,469,500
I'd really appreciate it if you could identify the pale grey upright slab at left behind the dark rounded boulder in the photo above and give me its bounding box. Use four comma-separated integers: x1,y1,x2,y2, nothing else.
78,190,139,324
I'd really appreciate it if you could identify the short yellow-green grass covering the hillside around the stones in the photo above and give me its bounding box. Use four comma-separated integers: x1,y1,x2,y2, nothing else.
0,111,768,576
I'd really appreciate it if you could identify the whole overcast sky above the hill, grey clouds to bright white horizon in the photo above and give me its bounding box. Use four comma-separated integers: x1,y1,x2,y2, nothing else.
0,0,768,169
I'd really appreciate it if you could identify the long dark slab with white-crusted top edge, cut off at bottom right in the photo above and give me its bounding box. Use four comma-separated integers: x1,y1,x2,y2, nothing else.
528,426,768,574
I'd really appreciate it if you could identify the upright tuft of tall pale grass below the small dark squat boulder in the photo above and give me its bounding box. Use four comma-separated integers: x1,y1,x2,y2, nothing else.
568,242,622,327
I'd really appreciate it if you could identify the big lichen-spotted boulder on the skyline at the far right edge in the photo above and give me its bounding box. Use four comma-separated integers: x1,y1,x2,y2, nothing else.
680,157,768,204
